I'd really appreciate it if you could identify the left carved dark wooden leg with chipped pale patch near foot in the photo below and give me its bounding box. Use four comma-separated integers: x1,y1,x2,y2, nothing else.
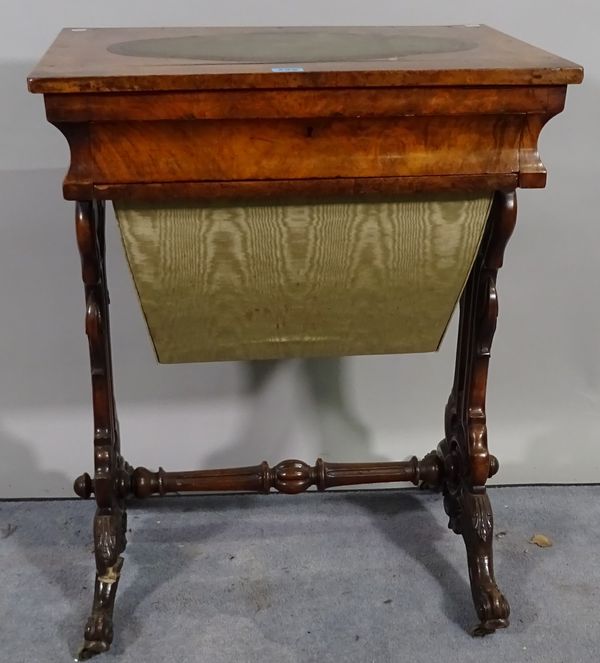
75,201,130,660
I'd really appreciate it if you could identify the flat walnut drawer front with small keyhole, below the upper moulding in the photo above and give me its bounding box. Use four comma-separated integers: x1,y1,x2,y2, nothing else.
90,115,522,184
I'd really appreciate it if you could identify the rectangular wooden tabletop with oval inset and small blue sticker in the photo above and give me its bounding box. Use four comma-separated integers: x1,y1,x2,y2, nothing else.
28,25,583,93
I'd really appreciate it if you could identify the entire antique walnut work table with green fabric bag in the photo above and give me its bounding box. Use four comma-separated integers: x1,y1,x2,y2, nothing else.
29,26,583,658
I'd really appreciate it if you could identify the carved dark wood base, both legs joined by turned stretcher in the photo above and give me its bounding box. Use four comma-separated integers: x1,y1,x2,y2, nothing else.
74,192,516,659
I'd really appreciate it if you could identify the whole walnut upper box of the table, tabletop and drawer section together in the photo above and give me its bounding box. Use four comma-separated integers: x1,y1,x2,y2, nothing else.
29,25,583,204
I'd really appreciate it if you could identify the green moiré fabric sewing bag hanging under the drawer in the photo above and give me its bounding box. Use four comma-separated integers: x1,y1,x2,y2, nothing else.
115,195,491,363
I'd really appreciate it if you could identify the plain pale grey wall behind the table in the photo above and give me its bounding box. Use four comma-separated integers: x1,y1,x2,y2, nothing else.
0,0,600,497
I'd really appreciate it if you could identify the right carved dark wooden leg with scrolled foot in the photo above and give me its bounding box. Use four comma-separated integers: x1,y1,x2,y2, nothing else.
438,191,517,635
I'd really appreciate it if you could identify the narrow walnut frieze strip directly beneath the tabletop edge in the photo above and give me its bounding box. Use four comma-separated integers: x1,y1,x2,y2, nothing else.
45,85,566,122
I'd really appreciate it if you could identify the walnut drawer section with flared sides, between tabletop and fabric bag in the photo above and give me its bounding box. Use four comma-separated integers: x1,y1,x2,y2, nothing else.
46,80,566,204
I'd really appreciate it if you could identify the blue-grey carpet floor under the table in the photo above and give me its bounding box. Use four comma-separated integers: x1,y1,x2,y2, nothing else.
0,486,600,663
